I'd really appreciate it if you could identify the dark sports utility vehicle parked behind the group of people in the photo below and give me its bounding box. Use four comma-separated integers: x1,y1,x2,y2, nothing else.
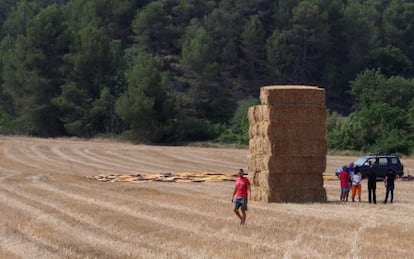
335,155,404,178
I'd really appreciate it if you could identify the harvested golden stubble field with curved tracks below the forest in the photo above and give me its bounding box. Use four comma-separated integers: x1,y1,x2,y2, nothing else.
0,137,414,259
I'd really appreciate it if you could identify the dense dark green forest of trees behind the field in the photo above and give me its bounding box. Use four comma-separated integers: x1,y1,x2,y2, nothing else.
0,0,414,154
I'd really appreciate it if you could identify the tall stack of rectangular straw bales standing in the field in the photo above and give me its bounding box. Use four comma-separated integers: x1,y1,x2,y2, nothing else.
248,86,327,202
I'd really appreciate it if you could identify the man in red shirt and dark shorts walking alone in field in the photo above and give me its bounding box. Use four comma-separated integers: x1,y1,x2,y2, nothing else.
231,169,250,225
